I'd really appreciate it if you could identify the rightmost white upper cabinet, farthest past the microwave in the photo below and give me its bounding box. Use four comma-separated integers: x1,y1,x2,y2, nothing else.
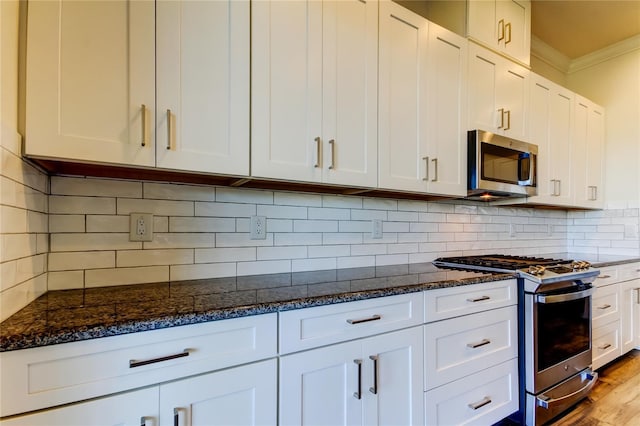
572,95,605,209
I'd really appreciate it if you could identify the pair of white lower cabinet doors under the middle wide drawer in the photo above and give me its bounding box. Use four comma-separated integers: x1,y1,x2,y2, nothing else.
280,327,423,425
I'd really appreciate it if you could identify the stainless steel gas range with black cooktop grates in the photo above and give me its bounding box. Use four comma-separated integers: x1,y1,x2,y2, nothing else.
433,255,600,426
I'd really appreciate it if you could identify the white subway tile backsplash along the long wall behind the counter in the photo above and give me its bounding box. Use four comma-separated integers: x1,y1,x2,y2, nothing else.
49,177,568,292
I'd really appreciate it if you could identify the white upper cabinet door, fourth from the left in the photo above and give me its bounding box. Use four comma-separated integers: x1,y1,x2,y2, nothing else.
322,0,378,187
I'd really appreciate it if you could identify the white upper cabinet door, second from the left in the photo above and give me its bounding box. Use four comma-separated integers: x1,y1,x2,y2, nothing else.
156,0,250,175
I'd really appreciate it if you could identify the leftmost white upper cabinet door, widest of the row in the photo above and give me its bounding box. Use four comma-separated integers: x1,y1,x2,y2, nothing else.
25,1,155,166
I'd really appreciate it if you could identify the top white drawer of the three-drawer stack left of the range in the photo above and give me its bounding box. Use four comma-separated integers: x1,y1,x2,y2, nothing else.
424,278,518,322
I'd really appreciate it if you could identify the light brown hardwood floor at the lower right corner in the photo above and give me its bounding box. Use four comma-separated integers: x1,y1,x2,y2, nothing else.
550,350,640,426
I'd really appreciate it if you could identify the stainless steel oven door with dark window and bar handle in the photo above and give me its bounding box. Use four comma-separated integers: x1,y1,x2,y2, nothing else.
525,283,594,394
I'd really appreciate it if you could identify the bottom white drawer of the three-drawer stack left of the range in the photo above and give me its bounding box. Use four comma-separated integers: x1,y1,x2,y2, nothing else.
425,359,518,425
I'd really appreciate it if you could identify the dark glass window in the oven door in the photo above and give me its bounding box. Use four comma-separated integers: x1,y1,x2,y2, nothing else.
536,297,591,371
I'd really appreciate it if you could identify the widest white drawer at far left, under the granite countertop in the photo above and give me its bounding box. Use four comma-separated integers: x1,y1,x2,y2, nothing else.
0,314,277,416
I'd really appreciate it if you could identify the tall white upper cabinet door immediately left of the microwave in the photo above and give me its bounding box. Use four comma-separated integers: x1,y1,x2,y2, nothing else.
425,24,468,196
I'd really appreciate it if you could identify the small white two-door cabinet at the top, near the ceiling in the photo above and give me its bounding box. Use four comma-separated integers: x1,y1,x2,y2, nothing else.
467,0,531,65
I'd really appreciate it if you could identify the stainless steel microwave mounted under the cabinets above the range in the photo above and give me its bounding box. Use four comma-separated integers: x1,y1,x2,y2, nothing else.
467,130,538,200
